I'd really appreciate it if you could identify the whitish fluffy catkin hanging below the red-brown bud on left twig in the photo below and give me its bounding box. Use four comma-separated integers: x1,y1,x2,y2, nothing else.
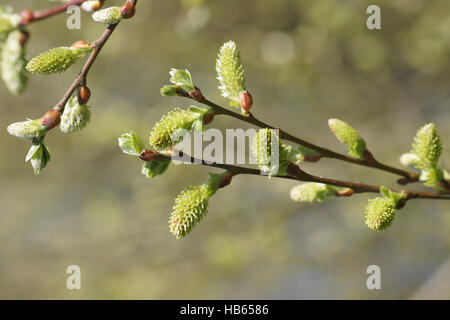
60,94,92,132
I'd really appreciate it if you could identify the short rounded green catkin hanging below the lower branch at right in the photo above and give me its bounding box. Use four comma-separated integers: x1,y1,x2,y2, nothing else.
365,198,397,231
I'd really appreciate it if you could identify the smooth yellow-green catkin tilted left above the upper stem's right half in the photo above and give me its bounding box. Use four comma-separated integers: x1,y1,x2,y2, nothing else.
328,119,373,161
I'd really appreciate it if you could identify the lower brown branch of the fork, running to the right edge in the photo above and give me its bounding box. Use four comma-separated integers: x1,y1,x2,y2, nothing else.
157,149,450,200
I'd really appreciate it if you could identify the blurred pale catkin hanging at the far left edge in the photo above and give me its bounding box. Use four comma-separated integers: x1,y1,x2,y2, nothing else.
0,30,28,95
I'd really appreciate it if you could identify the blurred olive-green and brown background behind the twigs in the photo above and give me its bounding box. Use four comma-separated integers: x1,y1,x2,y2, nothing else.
0,0,450,299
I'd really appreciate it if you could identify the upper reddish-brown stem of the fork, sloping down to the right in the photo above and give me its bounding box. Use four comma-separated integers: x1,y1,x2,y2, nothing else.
192,94,419,183
